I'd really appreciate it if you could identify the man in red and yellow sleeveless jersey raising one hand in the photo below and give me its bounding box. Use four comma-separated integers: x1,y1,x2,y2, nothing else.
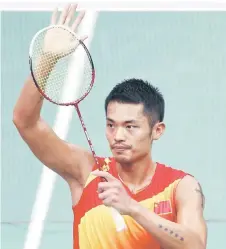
13,5,207,249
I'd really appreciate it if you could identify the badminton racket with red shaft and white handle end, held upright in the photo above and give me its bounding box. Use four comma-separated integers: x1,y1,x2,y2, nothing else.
29,25,125,231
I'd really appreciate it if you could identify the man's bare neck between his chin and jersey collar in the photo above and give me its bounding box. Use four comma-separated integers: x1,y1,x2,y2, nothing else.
116,155,156,186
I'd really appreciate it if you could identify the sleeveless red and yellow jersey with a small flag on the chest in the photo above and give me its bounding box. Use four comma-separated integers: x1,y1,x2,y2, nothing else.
73,158,187,249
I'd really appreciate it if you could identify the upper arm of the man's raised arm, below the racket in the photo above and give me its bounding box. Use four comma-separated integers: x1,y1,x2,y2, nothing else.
18,119,94,184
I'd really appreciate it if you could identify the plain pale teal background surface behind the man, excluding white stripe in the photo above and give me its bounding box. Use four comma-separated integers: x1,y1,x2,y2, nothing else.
1,12,226,249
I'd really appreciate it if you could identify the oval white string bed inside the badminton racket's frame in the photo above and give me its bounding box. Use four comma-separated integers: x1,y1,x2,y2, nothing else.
32,26,93,104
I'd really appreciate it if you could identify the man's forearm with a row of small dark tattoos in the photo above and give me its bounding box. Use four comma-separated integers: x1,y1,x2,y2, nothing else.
130,203,205,249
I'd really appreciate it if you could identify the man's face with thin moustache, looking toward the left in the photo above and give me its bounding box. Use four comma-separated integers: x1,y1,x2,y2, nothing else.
106,102,152,164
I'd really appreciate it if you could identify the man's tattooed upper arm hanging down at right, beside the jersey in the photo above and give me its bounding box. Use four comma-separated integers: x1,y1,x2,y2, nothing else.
176,176,207,247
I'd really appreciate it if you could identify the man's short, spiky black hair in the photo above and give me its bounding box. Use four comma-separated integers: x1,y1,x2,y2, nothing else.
105,78,165,127
